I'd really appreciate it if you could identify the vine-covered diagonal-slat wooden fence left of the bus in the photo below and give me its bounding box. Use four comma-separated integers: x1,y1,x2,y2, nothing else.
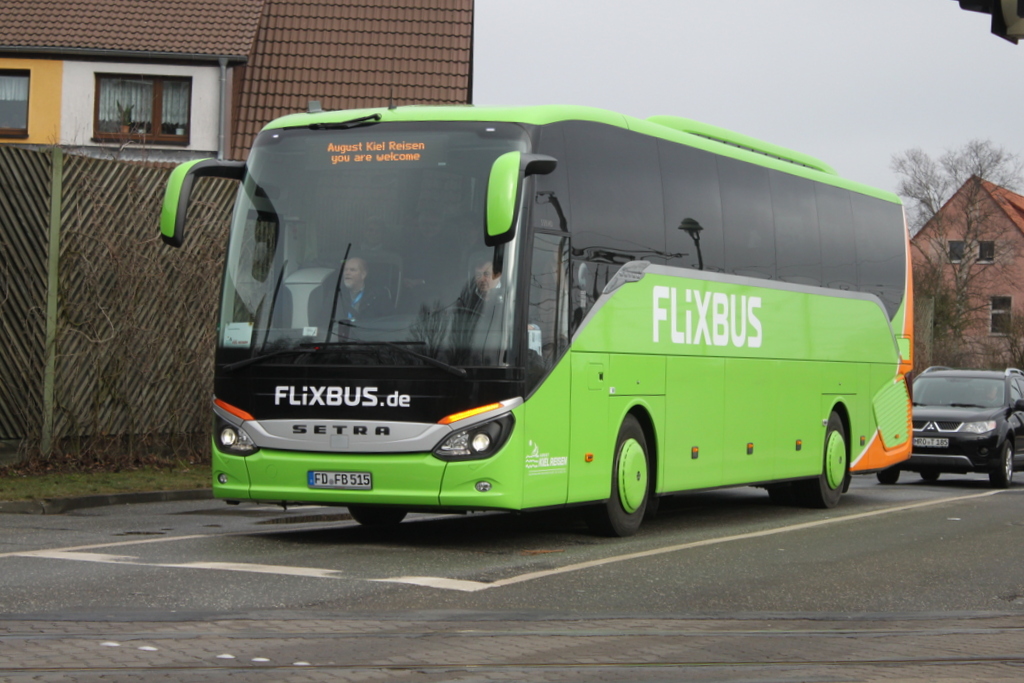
0,145,236,462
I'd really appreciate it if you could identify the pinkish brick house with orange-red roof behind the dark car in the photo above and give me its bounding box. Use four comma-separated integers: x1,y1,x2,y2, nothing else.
911,176,1024,367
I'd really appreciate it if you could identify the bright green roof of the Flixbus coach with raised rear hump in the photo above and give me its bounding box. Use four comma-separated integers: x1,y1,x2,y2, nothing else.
264,104,901,204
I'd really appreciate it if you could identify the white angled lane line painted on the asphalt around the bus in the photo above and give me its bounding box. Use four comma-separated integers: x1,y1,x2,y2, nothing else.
0,489,1006,593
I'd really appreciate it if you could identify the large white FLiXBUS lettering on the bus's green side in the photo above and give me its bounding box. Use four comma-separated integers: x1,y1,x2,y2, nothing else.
653,286,763,348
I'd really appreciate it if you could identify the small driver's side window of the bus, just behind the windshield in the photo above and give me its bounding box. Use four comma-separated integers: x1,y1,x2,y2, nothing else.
525,232,569,392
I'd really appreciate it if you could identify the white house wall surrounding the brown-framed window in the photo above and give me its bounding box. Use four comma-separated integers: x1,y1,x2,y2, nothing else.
60,61,220,156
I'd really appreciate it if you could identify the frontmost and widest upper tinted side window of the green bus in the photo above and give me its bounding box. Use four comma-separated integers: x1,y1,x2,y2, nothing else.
564,122,665,264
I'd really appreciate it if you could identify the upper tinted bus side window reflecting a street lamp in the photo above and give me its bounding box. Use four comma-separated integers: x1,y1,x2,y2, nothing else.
658,141,725,272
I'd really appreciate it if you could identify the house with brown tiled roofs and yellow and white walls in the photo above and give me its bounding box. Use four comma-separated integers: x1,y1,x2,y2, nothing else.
0,0,473,161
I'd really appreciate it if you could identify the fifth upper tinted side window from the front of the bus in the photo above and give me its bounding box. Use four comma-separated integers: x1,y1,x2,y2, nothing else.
814,184,856,290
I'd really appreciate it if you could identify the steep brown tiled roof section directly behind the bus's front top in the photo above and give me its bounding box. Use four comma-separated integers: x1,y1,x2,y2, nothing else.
230,0,473,159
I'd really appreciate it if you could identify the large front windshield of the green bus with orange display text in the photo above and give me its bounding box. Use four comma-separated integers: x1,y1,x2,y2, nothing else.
218,122,528,367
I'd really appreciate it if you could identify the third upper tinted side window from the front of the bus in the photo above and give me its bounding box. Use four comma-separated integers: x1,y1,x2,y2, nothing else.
718,158,775,279
